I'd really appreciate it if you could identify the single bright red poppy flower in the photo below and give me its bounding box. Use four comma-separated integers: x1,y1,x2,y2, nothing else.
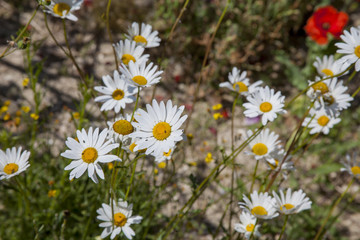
304,6,349,45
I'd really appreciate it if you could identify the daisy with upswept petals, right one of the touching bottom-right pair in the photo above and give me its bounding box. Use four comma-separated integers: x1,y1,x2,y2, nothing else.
273,188,311,215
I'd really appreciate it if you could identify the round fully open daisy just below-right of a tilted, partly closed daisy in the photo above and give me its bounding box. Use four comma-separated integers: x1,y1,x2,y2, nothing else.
243,86,286,125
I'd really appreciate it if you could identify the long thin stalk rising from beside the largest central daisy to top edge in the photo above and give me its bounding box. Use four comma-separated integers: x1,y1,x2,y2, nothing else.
184,0,230,133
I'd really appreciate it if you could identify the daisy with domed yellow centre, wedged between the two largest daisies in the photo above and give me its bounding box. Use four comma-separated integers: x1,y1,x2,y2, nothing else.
107,114,134,142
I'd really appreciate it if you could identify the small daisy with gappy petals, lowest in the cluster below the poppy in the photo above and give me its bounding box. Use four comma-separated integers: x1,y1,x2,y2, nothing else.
302,108,341,135
